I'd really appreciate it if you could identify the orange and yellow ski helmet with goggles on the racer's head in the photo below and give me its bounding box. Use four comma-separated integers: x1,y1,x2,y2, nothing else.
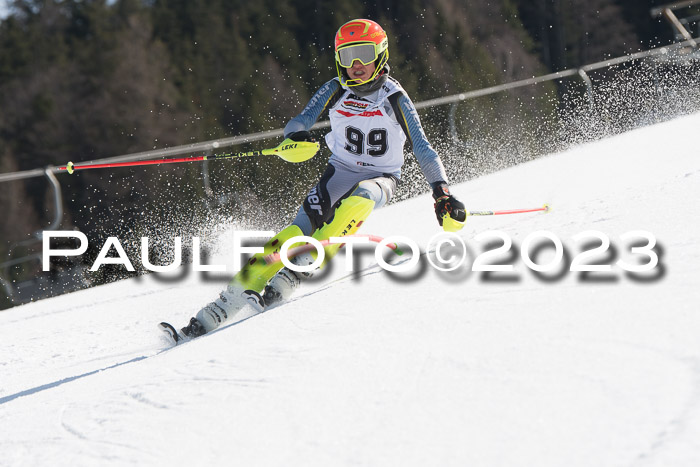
335,19,389,86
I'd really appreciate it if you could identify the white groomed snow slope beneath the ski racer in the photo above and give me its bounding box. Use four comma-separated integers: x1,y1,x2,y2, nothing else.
0,114,700,466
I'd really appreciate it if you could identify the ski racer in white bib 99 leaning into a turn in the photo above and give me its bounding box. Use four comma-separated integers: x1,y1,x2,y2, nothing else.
174,19,466,337
